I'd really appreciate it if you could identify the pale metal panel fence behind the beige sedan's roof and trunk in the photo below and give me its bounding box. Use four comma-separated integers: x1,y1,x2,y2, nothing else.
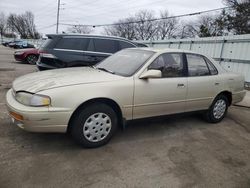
140,34,250,82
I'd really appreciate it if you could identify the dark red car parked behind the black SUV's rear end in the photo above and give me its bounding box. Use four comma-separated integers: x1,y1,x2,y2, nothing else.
14,48,39,65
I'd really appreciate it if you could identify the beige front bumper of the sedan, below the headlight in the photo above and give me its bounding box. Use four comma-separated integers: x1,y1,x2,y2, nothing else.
6,89,72,133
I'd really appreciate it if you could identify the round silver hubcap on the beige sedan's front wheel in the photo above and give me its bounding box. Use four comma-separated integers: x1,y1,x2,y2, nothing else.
83,112,112,142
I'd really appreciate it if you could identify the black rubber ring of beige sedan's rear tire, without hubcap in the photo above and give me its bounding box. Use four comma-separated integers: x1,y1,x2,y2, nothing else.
207,95,228,123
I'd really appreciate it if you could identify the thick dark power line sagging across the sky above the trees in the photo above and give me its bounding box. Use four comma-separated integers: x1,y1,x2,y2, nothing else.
60,6,232,27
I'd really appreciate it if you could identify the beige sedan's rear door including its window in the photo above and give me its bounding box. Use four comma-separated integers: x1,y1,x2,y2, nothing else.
186,54,219,111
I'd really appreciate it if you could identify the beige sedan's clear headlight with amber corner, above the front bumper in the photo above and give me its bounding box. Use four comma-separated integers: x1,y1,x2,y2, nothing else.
15,91,50,106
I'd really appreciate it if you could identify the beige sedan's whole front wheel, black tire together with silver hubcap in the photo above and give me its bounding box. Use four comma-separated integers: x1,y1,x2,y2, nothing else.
71,103,118,148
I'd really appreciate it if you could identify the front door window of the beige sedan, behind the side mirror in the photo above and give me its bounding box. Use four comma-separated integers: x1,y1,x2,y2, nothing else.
148,53,183,78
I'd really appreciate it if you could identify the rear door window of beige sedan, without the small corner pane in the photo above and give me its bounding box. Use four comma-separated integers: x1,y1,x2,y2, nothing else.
187,54,210,76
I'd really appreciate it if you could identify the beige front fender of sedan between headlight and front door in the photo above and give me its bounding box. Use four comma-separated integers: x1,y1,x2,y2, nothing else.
41,77,133,120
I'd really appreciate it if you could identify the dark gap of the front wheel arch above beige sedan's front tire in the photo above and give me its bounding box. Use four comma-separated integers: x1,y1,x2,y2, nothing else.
67,97,123,132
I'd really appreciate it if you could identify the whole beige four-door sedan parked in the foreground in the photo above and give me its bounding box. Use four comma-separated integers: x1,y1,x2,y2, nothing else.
6,48,245,147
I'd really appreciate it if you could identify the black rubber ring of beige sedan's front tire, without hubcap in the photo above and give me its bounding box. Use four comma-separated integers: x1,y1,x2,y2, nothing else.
71,103,118,148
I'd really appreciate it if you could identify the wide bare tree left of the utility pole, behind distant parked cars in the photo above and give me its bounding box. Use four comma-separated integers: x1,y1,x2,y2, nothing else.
7,11,40,38
